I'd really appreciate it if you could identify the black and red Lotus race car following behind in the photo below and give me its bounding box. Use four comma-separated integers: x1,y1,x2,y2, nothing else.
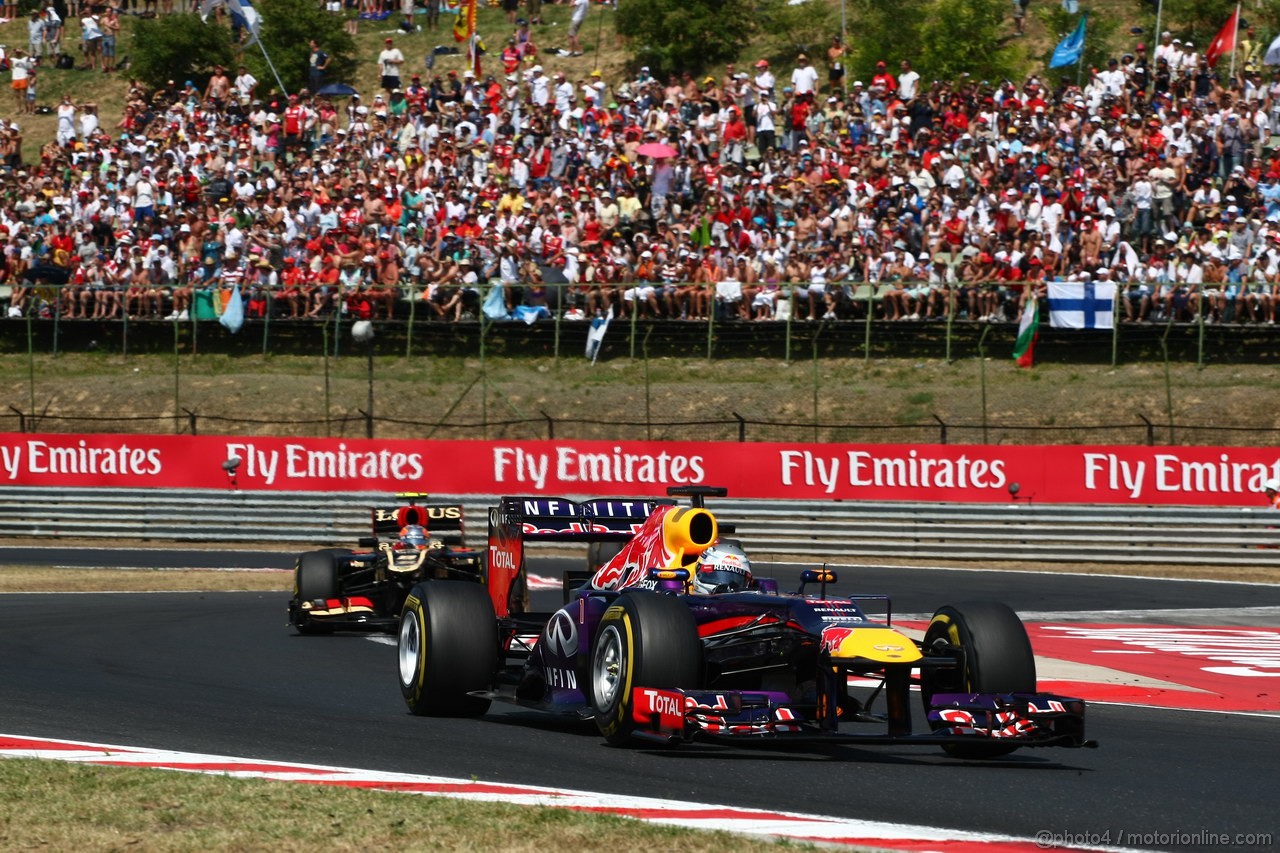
289,493,483,634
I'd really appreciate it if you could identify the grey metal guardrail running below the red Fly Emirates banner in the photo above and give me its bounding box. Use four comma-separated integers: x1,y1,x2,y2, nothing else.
0,487,1280,566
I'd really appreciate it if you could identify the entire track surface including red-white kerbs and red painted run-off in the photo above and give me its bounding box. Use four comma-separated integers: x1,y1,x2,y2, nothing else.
0,548,1280,850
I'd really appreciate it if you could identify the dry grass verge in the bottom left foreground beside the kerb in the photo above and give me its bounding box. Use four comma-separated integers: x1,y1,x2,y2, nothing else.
0,758,813,853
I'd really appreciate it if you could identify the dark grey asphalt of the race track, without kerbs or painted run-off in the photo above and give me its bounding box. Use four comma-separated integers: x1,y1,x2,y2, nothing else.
0,548,1280,848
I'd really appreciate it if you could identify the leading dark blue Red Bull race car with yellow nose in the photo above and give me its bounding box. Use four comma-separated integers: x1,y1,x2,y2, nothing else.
398,487,1094,758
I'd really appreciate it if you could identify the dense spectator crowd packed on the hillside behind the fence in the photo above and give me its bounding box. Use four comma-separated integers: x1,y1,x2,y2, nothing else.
0,19,1280,323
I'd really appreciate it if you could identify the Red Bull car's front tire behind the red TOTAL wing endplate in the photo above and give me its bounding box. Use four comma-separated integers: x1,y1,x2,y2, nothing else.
588,589,703,747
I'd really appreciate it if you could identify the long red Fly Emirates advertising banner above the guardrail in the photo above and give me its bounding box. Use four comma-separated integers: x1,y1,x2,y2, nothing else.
0,433,1280,506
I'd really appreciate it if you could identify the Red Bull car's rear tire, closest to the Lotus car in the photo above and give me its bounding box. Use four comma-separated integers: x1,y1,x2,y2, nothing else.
397,580,498,717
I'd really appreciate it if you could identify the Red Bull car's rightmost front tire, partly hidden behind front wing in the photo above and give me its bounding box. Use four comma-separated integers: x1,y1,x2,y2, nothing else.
920,601,1036,758
